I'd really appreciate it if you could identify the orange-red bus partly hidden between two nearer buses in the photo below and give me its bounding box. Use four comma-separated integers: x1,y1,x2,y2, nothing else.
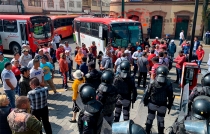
49,15,80,38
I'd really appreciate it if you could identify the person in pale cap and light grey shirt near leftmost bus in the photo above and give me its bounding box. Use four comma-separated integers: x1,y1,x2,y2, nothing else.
20,49,32,66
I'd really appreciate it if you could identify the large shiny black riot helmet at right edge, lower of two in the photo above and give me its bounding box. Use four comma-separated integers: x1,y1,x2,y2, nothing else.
192,95,210,120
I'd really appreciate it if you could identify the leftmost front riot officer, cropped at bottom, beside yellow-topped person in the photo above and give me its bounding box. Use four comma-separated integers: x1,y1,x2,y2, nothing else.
78,84,103,134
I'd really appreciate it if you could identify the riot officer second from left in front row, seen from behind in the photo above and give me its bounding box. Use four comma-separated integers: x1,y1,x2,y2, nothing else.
96,70,117,125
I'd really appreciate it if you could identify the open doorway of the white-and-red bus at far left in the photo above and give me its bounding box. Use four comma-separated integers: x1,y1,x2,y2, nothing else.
18,22,28,45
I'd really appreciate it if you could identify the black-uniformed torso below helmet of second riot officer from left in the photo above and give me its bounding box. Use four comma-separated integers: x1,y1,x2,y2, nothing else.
98,83,116,116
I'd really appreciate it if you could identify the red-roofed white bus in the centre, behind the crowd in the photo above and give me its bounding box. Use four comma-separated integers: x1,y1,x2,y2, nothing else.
74,17,143,53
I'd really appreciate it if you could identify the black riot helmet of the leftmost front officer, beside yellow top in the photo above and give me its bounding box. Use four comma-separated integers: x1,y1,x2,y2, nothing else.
79,84,96,104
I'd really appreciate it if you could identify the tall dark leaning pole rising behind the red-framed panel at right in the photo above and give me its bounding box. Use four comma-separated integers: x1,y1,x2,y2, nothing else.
189,0,199,62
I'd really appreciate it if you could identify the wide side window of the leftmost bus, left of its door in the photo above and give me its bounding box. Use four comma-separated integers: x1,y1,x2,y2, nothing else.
3,20,18,33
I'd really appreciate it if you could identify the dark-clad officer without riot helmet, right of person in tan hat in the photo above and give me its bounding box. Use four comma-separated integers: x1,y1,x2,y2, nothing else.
85,62,101,90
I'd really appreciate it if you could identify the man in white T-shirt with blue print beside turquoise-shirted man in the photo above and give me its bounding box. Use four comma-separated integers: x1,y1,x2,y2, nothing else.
30,59,45,86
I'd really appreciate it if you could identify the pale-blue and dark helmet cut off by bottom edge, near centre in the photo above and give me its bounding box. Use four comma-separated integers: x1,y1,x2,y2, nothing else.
112,120,147,134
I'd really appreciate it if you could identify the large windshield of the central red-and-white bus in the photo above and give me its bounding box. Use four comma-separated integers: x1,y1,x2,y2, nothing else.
111,23,142,47
